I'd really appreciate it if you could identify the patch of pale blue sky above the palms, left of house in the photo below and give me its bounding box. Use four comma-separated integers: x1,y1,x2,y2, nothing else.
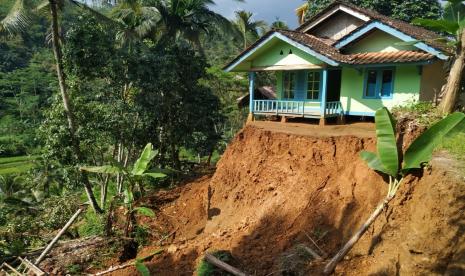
212,0,306,28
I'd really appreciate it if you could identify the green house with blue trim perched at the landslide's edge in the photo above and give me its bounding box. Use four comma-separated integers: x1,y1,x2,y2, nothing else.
224,2,451,124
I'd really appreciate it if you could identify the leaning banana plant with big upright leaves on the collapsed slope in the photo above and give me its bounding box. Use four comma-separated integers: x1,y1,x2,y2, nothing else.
324,108,465,274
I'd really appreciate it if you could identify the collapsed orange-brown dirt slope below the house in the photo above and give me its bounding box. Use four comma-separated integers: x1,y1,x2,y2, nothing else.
110,126,465,275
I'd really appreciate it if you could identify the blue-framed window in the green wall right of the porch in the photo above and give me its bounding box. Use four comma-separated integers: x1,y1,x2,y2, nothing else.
363,69,394,99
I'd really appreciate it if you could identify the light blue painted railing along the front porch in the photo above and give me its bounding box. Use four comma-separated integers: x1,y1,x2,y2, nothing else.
253,100,342,116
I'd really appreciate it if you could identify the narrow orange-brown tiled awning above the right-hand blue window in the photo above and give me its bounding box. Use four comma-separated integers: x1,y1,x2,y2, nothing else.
347,51,434,65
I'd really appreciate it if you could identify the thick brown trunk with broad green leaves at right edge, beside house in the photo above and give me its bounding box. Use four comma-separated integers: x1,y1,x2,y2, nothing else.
412,0,465,113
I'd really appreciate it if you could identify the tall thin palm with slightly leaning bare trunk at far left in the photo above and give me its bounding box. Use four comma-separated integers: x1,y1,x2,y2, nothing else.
0,0,102,213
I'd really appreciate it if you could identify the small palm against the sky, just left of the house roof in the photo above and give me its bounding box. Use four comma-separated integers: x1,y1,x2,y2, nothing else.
234,10,267,50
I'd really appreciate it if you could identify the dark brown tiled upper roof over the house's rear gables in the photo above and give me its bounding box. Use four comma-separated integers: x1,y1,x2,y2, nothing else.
296,1,451,53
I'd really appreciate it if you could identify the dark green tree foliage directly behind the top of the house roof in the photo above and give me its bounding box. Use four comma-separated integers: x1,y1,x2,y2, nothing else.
306,0,441,22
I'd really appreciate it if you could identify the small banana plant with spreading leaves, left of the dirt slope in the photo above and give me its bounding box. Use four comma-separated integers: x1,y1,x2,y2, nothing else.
80,143,166,236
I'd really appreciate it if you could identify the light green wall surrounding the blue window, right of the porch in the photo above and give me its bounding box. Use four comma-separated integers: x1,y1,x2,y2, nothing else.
341,66,421,113
